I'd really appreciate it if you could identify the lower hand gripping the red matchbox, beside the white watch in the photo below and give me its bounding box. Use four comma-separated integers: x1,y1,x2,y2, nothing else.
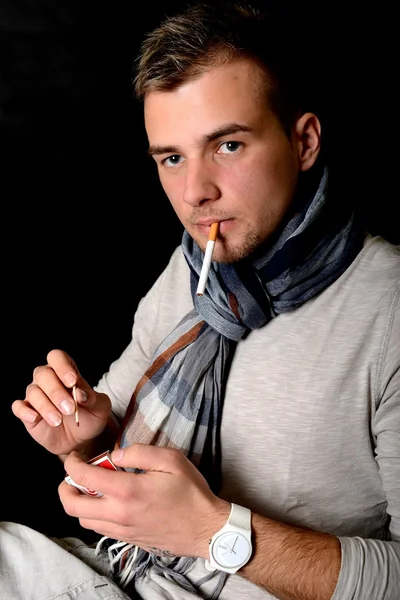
59,444,230,558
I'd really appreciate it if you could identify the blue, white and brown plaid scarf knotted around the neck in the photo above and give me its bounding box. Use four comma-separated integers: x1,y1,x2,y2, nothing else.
103,168,364,598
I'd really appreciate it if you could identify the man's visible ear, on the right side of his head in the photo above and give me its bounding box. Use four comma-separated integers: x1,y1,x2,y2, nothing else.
294,113,321,171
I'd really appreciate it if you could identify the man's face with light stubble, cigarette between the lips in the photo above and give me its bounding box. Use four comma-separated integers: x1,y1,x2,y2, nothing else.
144,60,308,262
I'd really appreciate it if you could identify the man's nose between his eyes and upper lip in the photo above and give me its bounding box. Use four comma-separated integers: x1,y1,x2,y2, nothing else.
183,163,221,206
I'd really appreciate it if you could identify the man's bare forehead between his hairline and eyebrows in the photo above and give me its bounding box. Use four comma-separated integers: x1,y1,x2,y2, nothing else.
144,59,269,143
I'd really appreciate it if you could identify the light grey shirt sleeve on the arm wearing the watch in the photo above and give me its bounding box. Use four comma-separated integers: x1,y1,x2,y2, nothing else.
332,286,400,600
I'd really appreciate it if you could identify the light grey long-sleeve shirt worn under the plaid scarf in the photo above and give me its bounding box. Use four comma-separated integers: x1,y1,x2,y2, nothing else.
96,236,400,600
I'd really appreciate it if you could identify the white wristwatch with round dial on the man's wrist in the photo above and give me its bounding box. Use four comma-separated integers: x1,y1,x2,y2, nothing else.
206,504,252,573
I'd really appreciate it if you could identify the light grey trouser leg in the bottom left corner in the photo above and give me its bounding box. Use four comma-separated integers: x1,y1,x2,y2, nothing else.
0,521,129,600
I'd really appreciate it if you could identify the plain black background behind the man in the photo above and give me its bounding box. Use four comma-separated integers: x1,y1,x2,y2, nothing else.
0,0,400,535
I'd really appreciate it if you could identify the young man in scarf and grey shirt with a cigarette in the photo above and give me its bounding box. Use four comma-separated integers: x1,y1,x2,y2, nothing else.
0,3,400,600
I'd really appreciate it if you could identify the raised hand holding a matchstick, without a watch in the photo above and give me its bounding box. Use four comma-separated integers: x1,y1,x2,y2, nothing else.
11,350,111,455
